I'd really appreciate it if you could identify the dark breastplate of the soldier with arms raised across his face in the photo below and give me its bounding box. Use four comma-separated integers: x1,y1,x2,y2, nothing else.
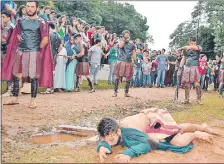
185,50,200,67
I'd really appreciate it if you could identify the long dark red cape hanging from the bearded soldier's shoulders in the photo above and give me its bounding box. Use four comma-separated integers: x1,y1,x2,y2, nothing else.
2,18,53,88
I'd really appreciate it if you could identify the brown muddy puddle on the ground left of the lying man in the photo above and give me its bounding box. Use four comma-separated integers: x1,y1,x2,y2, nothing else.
29,133,85,144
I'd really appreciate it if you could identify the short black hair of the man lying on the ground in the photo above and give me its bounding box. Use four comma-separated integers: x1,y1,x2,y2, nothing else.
97,118,119,137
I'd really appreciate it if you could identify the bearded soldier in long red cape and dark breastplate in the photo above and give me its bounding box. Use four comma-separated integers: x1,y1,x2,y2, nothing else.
2,1,53,108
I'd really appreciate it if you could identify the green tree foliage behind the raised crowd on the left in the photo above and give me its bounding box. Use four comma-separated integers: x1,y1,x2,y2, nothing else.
16,0,153,43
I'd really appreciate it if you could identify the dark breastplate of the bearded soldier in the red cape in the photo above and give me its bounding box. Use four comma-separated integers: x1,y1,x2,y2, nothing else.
19,18,41,51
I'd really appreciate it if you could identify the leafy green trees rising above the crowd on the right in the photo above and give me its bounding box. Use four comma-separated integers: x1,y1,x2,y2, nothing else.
170,1,224,58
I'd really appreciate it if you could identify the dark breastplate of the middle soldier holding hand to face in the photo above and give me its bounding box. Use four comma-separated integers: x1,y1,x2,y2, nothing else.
118,42,133,61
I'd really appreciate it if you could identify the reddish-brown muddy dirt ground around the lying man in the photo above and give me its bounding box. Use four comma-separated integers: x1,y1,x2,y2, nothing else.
2,88,224,163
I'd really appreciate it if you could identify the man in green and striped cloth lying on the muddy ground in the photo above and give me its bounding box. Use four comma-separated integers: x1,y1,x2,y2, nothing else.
97,108,219,163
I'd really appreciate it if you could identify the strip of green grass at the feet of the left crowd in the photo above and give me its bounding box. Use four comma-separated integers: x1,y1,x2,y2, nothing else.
1,80,125,94
